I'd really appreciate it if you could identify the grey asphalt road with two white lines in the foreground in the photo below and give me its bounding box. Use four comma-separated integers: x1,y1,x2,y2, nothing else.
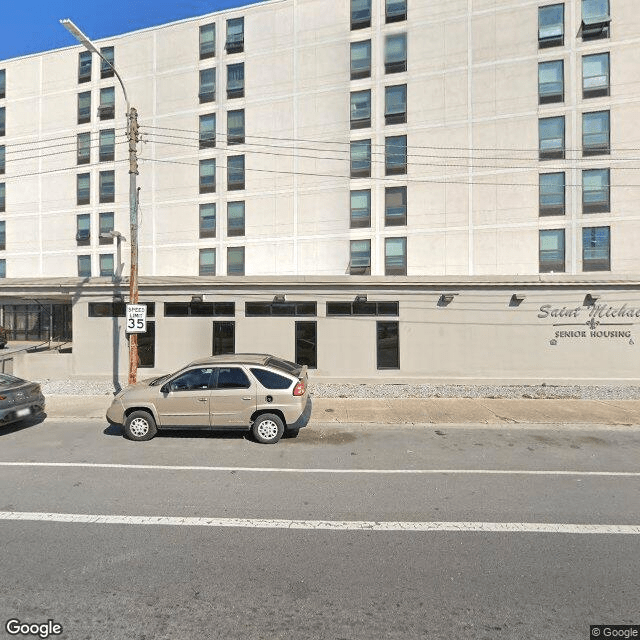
0,419,640,640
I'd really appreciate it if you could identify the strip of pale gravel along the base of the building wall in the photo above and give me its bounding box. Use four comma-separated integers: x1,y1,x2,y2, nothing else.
38,379,640,400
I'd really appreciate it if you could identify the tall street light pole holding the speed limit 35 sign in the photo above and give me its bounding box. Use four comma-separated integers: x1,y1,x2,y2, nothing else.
60,19,138,384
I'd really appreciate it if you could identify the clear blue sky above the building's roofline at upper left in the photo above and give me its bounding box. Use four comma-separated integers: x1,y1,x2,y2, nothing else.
0,0,262,60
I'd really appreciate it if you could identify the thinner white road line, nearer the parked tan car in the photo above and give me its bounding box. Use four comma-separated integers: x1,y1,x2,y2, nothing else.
0,462,640,478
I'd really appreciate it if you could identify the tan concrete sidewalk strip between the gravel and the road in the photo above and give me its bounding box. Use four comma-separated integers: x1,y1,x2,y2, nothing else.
41,395,640,425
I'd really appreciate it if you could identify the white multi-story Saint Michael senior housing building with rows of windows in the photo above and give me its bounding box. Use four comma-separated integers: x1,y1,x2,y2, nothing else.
0,0,640,379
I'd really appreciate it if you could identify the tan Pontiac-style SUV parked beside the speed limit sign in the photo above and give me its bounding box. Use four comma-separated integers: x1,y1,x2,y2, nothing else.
107,353,311,444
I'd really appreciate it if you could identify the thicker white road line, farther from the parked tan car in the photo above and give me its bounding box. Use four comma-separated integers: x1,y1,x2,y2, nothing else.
0,511,640,535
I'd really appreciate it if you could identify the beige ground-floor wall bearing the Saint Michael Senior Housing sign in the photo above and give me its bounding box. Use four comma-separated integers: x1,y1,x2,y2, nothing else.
61,281,640,384
